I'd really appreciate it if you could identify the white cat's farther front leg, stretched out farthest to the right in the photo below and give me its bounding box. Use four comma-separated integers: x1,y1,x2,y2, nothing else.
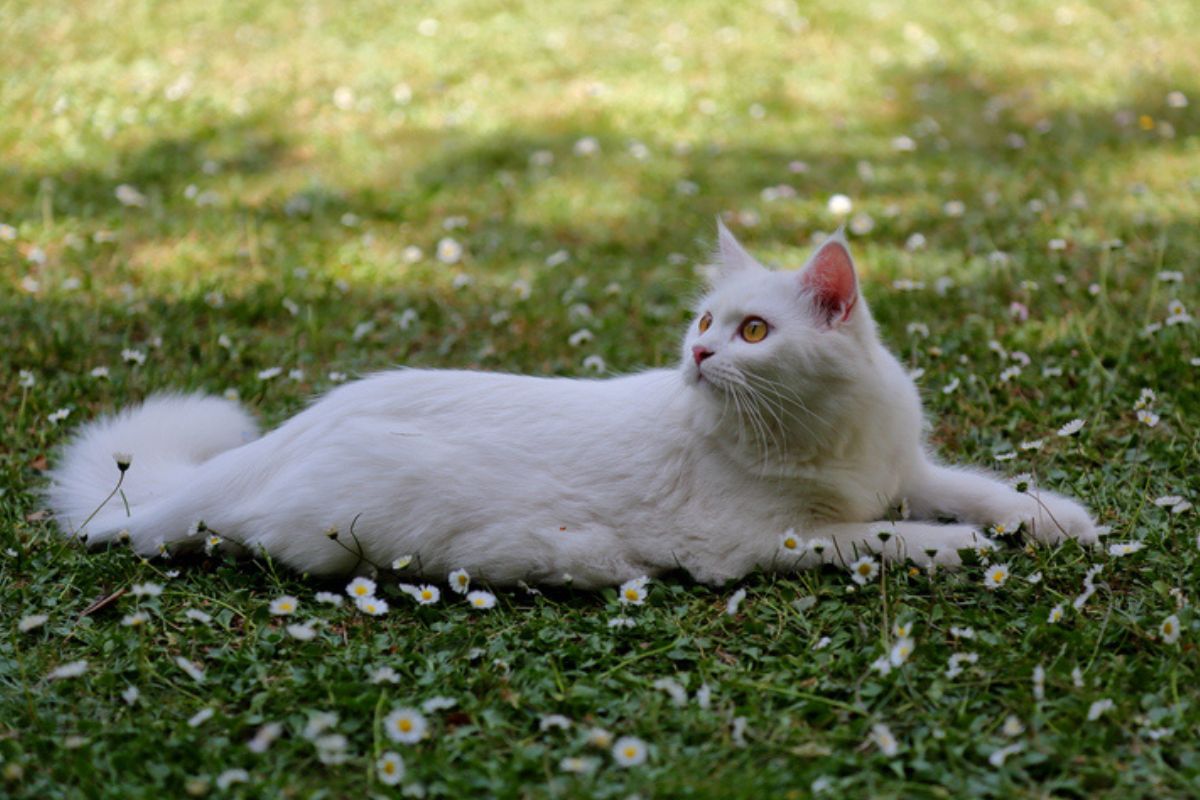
904,462,1099,545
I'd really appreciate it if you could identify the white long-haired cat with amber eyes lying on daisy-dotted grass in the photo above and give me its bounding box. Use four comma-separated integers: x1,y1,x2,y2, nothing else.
48,227,1097,587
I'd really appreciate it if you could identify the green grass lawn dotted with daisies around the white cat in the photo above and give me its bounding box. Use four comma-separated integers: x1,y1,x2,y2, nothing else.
0,0,1200,798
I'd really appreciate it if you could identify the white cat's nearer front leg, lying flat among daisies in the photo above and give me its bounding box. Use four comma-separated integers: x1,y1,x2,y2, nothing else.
803,521,995,567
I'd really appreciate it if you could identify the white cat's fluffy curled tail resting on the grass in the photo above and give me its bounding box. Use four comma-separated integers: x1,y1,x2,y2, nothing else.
46,395,258,543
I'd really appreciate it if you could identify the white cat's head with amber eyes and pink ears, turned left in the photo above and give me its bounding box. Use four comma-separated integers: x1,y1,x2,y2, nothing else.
680,224,880,438
